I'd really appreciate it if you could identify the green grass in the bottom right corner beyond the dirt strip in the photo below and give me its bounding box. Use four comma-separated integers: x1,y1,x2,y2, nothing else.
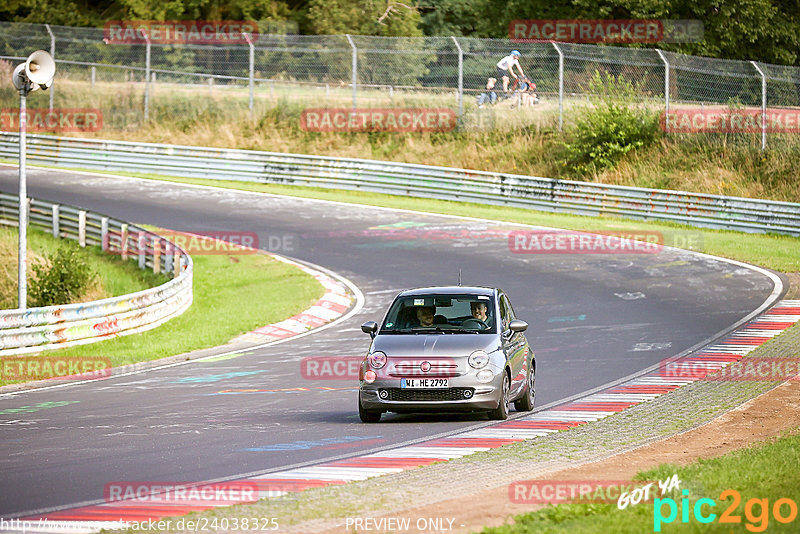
482,435,800,534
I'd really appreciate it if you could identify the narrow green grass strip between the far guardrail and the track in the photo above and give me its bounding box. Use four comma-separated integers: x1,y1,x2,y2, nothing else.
39,168,800,272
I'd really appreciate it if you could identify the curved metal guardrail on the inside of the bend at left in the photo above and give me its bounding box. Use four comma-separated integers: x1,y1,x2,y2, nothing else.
0,193,193,356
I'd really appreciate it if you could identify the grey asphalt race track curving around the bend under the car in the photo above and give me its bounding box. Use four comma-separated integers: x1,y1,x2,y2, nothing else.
0,166,774,517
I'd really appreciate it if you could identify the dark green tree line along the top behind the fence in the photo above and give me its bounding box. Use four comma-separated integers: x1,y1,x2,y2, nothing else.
0,0,800,65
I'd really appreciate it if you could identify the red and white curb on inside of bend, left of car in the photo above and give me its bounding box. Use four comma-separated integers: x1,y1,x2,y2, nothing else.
236,255,353,343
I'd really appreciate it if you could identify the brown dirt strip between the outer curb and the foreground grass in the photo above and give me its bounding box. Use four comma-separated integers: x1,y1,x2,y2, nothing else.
326,378,800,533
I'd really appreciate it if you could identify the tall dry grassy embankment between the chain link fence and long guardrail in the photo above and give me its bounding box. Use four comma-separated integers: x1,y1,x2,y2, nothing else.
0,79,800,202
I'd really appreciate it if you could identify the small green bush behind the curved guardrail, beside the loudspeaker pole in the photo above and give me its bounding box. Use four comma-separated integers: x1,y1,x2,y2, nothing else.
28,245,98,307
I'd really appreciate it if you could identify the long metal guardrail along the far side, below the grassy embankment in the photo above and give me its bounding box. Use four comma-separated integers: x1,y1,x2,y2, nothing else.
0,133,800,236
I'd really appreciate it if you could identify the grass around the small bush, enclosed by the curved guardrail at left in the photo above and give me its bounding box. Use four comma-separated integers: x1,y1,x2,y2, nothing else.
0,226,168,309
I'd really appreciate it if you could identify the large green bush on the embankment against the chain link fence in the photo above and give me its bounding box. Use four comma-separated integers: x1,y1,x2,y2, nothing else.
564,71,662,175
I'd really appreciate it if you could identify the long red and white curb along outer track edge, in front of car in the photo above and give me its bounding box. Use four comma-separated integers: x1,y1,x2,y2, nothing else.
15,302,800,532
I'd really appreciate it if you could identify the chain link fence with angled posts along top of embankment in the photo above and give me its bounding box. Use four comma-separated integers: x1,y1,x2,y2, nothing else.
0,22,800,148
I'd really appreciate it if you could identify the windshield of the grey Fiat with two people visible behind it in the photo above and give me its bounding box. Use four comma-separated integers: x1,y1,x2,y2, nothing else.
381,294,496,334
